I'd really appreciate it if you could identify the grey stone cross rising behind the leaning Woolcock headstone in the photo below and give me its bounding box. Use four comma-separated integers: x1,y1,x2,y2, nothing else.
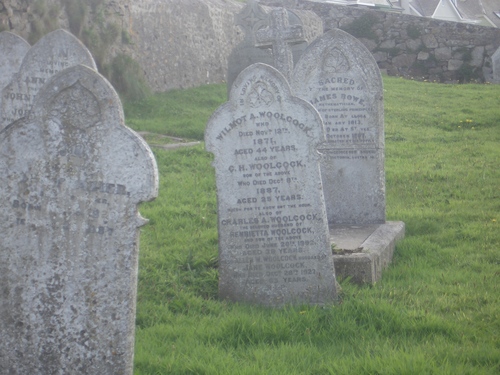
255,8,305,81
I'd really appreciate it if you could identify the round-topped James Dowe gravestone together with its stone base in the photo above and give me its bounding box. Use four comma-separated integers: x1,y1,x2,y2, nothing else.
292,30,404,282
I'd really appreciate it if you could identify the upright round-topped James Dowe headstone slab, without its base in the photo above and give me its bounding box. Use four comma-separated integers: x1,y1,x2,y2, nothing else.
292,29,385,225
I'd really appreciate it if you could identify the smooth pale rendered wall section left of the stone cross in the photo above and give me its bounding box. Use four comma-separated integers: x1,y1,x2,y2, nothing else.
130,0,243,91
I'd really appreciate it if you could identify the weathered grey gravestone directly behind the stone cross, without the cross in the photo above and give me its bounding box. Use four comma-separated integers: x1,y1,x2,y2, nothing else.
227,0,323,94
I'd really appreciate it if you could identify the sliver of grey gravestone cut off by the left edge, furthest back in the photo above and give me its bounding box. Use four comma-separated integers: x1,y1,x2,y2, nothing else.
0,31,30,117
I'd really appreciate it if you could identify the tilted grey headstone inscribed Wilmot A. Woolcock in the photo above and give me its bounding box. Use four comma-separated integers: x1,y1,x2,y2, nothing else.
205,64,337,306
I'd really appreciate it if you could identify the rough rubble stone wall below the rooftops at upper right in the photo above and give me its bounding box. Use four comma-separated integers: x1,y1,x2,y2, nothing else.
261,0,500,82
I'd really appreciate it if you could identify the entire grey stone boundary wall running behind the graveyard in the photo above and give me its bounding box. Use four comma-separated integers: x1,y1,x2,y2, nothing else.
0,0,500,92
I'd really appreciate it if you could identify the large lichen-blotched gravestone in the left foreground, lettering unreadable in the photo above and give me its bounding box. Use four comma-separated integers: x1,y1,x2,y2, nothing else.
0,65,158,375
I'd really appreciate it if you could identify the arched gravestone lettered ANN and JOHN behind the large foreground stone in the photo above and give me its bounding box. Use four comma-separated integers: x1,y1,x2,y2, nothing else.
0,29,97,130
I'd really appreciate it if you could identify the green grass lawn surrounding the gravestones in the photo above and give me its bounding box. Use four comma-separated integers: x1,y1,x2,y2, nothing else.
126,77,500,375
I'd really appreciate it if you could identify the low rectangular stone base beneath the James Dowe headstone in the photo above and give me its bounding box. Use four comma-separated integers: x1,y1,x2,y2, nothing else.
330,221,405,284
